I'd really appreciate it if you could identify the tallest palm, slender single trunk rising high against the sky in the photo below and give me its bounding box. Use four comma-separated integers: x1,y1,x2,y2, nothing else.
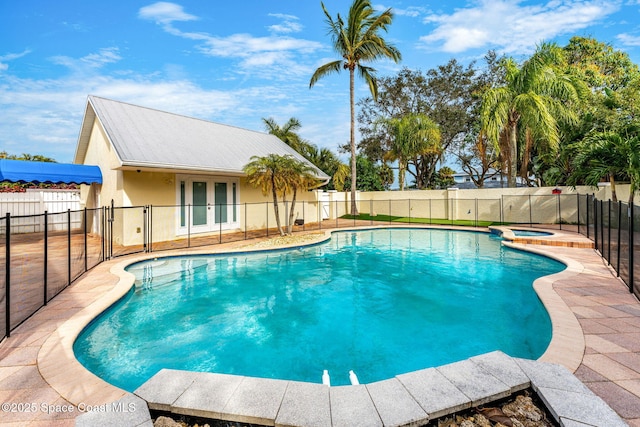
309,0,401,215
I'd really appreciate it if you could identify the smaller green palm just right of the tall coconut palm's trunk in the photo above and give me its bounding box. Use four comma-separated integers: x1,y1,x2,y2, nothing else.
385,114,440,191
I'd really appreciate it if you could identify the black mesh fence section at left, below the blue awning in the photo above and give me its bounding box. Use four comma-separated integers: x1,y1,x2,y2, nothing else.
0,209,105,339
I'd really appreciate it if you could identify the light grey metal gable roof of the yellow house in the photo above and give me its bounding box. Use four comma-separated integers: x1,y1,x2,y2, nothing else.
75,96,329,179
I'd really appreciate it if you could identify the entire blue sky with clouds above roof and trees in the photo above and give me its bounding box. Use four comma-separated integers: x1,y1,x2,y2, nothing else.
0,0,640,162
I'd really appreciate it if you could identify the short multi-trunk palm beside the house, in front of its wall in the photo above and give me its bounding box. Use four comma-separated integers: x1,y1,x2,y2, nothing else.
243,154,318,236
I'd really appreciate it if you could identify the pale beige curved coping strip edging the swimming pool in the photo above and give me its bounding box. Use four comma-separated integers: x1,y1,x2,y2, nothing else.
37,225,624,425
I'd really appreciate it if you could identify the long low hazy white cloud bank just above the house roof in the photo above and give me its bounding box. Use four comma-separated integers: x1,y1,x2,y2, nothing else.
0,53,348,162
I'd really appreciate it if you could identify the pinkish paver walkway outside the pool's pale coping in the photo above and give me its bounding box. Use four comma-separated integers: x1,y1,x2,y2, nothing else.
0,226,640,427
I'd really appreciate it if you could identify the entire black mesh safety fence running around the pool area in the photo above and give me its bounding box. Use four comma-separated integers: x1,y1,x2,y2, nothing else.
0,194,640,339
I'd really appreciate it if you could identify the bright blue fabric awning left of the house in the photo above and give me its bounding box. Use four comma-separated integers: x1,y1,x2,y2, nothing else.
0,159,102,184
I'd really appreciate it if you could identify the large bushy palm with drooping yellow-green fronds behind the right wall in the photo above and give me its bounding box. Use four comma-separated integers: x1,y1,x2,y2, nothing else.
480,43,586,187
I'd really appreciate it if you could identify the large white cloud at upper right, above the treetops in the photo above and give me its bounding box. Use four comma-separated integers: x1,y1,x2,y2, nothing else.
420,0,620,53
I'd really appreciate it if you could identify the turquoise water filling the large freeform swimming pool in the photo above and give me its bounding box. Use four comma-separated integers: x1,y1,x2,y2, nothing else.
74,229,564,391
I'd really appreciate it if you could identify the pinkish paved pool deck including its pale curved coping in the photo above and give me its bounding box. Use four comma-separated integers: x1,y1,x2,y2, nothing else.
0,227,640,426
